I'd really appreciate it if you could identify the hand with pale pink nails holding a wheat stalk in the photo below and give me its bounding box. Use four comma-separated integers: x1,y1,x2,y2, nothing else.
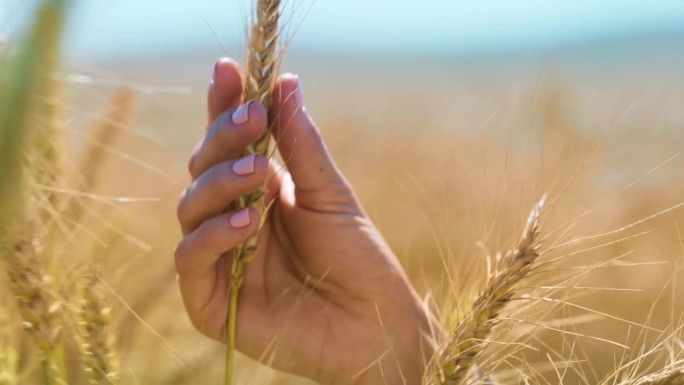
175,59,441,384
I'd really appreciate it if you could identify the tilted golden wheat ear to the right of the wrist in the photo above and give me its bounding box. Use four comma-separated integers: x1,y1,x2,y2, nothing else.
427,198,545,385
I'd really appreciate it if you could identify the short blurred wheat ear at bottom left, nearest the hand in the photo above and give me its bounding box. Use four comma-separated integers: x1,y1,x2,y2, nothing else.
78,273,119,385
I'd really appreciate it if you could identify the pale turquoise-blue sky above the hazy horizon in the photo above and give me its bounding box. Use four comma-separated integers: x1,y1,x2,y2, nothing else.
0,0,684,60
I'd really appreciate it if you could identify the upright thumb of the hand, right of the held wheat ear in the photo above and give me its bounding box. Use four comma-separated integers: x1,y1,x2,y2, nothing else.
272,74,346,192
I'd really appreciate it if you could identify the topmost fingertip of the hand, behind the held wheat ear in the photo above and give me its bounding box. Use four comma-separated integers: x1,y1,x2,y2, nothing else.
207,58,242,124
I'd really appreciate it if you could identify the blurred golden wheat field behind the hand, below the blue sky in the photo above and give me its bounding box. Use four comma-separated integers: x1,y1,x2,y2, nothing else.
0,1,684,385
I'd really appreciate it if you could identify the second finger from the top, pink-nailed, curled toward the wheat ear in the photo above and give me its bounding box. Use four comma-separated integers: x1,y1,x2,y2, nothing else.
188,101,268,180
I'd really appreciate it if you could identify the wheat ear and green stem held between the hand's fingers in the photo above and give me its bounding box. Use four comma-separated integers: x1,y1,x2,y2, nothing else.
225,0,280,385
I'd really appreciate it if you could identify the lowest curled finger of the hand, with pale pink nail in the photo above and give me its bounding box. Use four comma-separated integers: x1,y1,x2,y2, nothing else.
175,208,259,281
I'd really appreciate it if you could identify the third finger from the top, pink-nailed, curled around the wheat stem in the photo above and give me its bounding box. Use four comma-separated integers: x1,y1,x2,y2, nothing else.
177,154,269,234
